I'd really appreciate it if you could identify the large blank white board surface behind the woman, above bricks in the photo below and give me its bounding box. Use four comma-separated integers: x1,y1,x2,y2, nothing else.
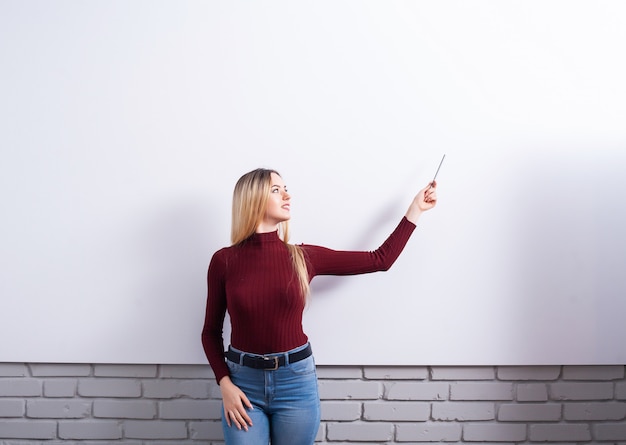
0,0,626,365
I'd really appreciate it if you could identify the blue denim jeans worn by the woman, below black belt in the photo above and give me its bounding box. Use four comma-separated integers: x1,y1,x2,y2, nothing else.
222,345,320,445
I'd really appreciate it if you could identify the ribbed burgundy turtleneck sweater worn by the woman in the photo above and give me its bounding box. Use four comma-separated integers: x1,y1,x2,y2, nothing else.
202,217,415,382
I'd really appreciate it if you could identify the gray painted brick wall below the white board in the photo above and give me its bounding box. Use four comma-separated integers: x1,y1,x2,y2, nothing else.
0,363,626,445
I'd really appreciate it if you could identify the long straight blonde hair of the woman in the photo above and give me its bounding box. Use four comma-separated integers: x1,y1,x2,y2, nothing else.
230,168,310,301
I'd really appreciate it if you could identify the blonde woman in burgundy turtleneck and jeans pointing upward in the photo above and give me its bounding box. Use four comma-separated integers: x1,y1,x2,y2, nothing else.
202,169,437,445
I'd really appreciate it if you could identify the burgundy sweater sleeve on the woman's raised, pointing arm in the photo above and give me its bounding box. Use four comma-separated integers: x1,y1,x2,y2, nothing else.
303,217,416,278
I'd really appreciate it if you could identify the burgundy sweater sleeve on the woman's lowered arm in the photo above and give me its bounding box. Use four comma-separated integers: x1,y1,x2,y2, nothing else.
202,251,229,383
